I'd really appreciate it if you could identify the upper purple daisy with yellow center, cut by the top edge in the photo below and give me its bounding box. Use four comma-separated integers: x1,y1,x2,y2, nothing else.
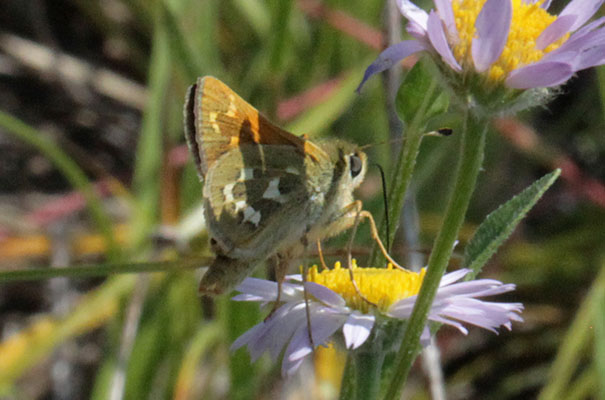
358,0,605,90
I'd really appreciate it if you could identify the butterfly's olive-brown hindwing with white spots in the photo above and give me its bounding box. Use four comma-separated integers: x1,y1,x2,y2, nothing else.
204,145,330,257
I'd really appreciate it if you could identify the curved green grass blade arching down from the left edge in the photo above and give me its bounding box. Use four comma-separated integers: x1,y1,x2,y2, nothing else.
0,111,120,261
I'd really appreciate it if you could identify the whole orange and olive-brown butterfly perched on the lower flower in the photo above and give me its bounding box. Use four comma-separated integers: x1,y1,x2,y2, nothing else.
184,76,367,295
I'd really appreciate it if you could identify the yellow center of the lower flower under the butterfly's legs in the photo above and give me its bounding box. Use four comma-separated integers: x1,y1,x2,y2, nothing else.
307,260,425,313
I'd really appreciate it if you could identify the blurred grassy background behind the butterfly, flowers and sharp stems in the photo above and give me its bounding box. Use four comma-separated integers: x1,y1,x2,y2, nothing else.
0,0,605,399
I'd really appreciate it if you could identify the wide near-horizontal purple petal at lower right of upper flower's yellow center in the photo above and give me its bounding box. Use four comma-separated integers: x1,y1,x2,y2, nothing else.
505,61,574,89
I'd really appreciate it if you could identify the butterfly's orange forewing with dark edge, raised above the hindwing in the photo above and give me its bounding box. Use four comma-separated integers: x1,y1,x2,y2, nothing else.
184,76,326,178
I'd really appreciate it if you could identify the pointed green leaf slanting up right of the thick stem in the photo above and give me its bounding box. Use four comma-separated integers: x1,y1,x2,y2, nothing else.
462,169,561,276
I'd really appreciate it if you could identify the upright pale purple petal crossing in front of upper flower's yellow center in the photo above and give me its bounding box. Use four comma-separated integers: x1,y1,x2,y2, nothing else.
471,0,513,72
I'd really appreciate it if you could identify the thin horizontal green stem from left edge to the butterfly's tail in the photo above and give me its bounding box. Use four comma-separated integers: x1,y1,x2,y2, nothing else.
0,259,205,283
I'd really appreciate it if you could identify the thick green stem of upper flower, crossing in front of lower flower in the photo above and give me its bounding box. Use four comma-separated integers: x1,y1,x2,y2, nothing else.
385,110,487,399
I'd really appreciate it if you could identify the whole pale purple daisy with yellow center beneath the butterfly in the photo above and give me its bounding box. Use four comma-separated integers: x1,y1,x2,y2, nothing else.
231,262,523,376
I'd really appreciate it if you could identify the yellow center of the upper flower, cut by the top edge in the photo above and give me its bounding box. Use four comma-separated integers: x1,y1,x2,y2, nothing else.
452,0,569,82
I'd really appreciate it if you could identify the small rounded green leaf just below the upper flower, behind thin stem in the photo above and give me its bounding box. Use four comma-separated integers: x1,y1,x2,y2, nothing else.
395,60,449,126
